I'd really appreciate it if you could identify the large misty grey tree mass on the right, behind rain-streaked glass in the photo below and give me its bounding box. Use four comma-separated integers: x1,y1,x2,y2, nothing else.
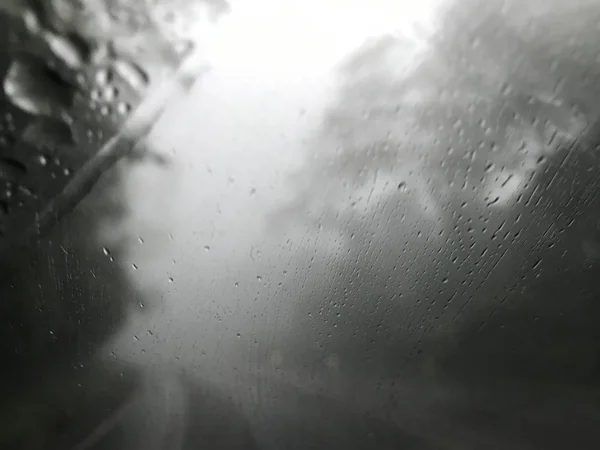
279,1,600,381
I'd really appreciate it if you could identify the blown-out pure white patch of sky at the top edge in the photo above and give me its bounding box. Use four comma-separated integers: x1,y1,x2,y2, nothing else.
190,0,442,73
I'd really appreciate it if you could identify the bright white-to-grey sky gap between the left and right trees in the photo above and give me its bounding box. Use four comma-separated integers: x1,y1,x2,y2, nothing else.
111,0,450,362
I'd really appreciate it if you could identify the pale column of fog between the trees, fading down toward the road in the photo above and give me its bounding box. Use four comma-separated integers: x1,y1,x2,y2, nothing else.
108,2,440,376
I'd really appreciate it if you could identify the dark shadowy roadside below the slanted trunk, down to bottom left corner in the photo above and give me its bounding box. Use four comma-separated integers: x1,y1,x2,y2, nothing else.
0,149,254,450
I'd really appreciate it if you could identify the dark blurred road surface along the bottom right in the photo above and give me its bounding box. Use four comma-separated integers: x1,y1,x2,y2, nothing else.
188,370,600,450
